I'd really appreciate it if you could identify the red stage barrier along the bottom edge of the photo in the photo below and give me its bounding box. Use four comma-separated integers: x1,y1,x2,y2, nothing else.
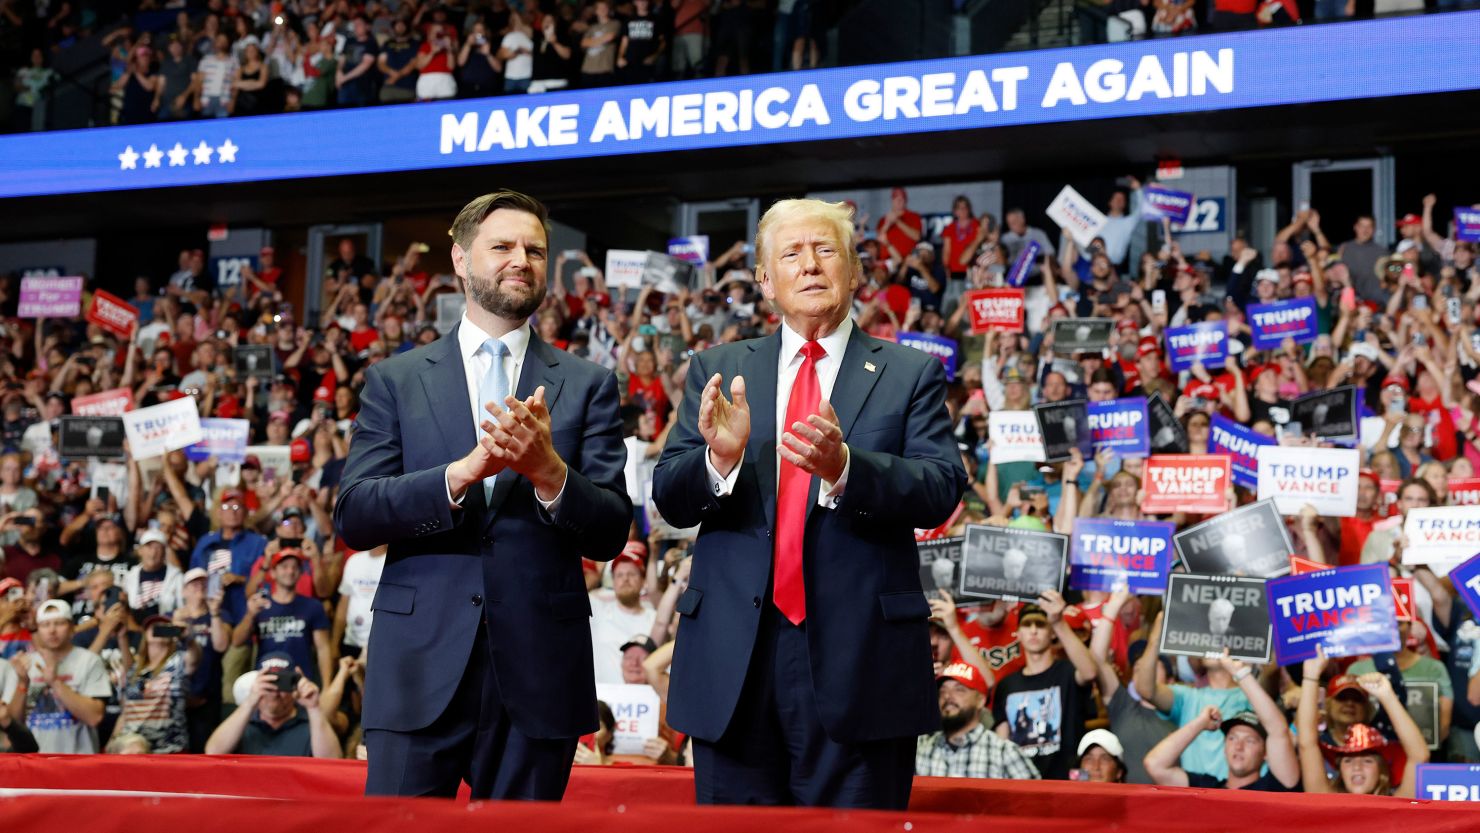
0,755,1480,833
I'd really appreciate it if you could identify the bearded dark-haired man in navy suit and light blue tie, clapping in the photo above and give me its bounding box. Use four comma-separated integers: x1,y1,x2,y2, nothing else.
334,192,632,800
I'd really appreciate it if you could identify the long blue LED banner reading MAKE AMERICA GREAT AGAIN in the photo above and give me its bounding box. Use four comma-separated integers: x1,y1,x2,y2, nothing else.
0,12,1480,197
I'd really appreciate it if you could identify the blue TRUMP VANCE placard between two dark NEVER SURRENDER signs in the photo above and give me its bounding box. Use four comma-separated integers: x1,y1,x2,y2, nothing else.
1069,518,1177,596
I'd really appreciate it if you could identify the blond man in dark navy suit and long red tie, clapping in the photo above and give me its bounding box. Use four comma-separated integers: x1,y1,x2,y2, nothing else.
653,200,966,809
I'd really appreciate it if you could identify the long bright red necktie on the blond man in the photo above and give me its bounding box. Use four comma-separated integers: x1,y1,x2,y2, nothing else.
771,342,827,624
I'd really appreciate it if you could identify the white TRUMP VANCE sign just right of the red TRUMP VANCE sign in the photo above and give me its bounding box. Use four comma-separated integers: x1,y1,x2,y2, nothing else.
1259,445,1362,518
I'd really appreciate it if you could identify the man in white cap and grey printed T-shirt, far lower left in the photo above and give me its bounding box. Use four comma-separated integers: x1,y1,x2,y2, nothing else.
9,599,112,755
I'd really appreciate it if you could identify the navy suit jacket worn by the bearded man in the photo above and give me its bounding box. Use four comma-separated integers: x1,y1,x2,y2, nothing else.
334,330,632,738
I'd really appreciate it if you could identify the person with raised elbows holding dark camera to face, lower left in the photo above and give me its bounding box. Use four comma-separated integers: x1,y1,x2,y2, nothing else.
206,652,339,758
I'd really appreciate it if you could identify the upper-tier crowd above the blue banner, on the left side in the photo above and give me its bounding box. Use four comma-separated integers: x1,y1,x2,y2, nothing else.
0,0,836,132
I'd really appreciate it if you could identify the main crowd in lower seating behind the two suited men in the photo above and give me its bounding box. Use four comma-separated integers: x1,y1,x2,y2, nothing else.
0,178,1480,795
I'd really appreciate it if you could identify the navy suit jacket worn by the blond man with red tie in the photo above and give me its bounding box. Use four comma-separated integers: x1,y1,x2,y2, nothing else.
653,328,966,743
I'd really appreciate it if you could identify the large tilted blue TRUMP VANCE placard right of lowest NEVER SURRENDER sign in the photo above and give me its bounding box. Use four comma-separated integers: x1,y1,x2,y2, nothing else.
1268,564,1402,666
